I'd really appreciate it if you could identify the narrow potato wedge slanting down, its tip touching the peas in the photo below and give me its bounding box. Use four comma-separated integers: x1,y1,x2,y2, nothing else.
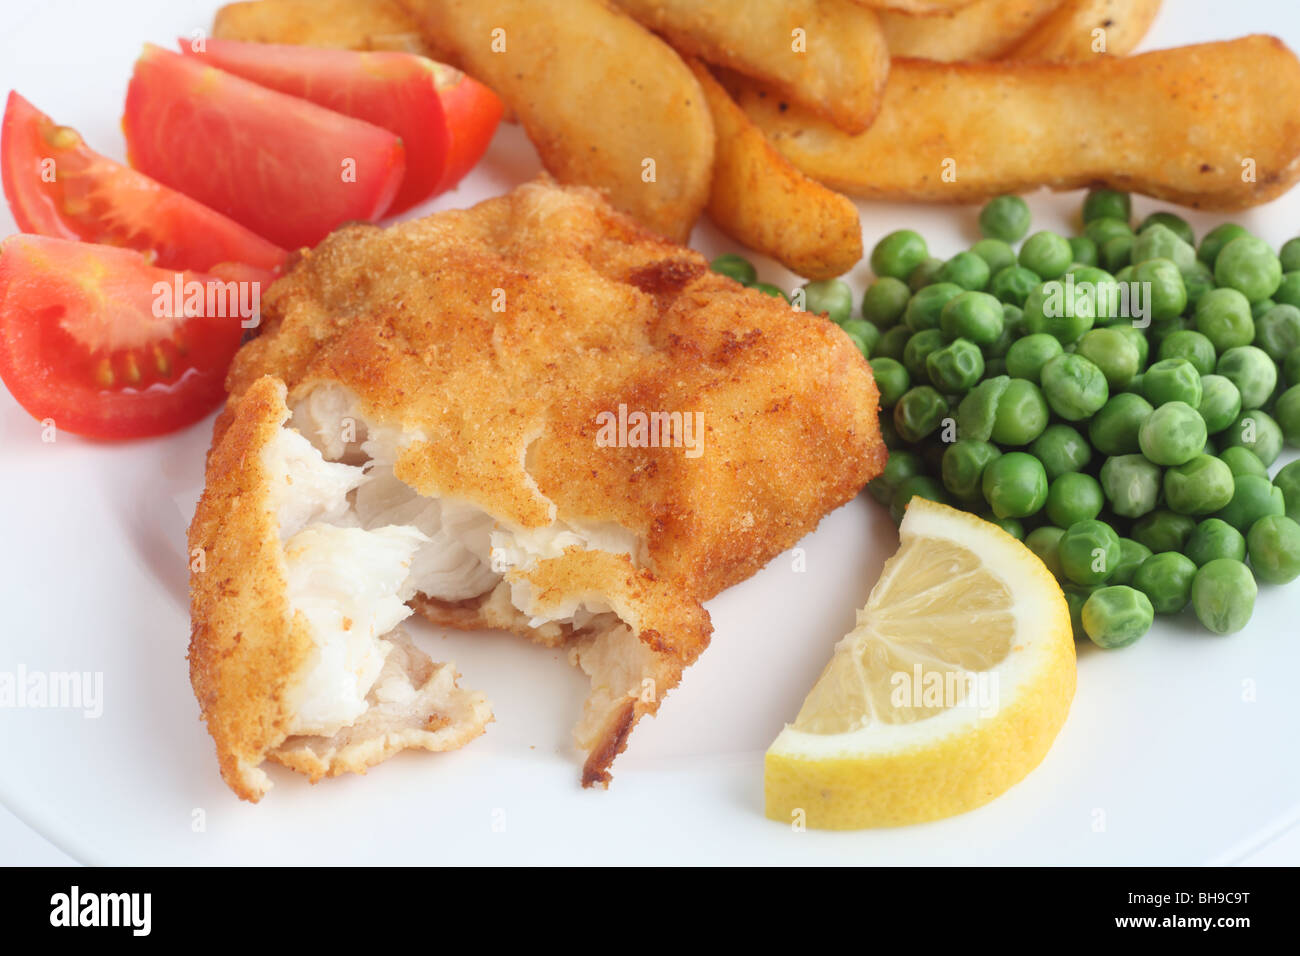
690,60,862,278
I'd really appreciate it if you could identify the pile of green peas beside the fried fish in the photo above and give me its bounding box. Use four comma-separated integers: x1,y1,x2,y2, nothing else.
714,190,1300,648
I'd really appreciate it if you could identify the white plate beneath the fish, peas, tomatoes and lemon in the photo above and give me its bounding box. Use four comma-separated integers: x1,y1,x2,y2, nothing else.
0,0,1300,864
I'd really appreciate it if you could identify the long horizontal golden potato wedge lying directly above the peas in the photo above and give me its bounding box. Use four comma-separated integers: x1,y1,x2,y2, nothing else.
738,36,1300,209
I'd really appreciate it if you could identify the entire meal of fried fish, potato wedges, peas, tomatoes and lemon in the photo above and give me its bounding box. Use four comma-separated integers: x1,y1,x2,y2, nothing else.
0,0,1300,829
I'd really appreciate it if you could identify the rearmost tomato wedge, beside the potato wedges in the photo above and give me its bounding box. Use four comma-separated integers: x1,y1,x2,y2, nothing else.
178,39,504,215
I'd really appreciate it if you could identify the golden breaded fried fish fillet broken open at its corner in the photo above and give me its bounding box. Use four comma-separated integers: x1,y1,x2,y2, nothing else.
191,181,885,795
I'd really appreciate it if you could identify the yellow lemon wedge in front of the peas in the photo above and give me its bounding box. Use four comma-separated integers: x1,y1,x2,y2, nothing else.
764,497,1075,830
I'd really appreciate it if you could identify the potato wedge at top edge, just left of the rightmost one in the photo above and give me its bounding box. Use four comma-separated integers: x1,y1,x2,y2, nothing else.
880,0,1067,62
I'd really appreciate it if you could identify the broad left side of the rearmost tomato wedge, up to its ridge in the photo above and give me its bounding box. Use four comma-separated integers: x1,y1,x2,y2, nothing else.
178,38,451,216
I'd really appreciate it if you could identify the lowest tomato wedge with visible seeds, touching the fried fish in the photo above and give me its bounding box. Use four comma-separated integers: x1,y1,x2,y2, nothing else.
0,235,252,438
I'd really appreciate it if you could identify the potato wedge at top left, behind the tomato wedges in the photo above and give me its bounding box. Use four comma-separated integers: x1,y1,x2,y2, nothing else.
212,0,428,55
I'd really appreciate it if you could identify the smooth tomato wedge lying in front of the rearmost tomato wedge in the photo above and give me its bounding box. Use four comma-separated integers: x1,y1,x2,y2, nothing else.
122,44,406,248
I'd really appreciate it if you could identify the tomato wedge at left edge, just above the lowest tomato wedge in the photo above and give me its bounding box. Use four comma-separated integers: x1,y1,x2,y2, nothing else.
0,92,289,272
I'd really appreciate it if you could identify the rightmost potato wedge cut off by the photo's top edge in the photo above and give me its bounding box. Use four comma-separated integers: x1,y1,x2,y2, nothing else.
1005,0,1160,61
